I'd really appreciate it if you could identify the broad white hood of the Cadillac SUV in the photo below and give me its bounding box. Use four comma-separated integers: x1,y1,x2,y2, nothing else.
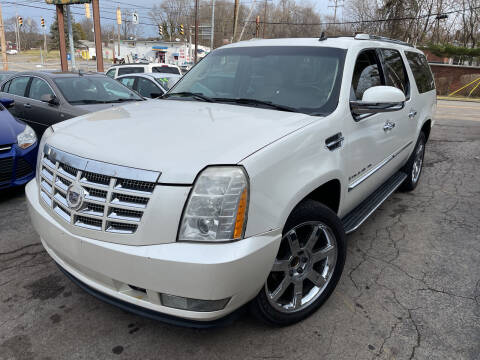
48,100,316,184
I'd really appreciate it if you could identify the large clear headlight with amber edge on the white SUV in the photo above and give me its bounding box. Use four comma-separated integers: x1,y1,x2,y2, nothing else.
178,166,249,241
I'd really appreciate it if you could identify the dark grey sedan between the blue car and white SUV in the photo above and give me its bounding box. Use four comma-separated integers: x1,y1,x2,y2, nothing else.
0,71,144,136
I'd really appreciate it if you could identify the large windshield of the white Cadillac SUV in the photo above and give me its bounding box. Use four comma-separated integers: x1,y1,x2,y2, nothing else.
169,46,346,115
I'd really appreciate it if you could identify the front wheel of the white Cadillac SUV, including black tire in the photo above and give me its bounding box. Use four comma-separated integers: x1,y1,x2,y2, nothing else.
250,200,346,326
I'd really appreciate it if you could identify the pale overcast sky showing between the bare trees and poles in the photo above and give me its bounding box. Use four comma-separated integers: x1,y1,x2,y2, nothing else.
1,0,342,36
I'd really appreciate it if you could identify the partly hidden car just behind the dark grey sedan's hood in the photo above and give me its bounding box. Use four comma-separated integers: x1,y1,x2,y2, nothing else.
117,73,182,99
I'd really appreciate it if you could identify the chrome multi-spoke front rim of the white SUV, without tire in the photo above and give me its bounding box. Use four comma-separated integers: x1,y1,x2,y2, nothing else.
265,222,337,313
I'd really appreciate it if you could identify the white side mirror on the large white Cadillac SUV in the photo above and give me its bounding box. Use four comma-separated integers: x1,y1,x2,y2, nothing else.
350,86,406,118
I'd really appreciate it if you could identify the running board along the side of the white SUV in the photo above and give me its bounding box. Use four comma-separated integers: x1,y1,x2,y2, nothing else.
342,171,407,234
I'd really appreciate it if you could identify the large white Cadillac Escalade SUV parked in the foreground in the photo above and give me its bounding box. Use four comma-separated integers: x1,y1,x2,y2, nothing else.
26,34,436,327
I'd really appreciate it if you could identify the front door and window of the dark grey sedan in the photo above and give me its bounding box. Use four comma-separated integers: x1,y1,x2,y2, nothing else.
24,76,61,135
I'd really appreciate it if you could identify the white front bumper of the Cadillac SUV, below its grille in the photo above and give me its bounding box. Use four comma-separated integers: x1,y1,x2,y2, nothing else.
25,180,281,321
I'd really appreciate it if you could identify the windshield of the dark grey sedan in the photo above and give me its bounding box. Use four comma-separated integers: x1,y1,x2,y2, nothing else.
54,76,143,105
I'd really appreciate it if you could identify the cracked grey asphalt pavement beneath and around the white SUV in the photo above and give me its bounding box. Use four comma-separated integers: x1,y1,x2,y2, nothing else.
0,101,480,360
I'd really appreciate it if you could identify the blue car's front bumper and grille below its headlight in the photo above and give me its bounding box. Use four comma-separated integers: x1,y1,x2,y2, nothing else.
0,144,38,189
